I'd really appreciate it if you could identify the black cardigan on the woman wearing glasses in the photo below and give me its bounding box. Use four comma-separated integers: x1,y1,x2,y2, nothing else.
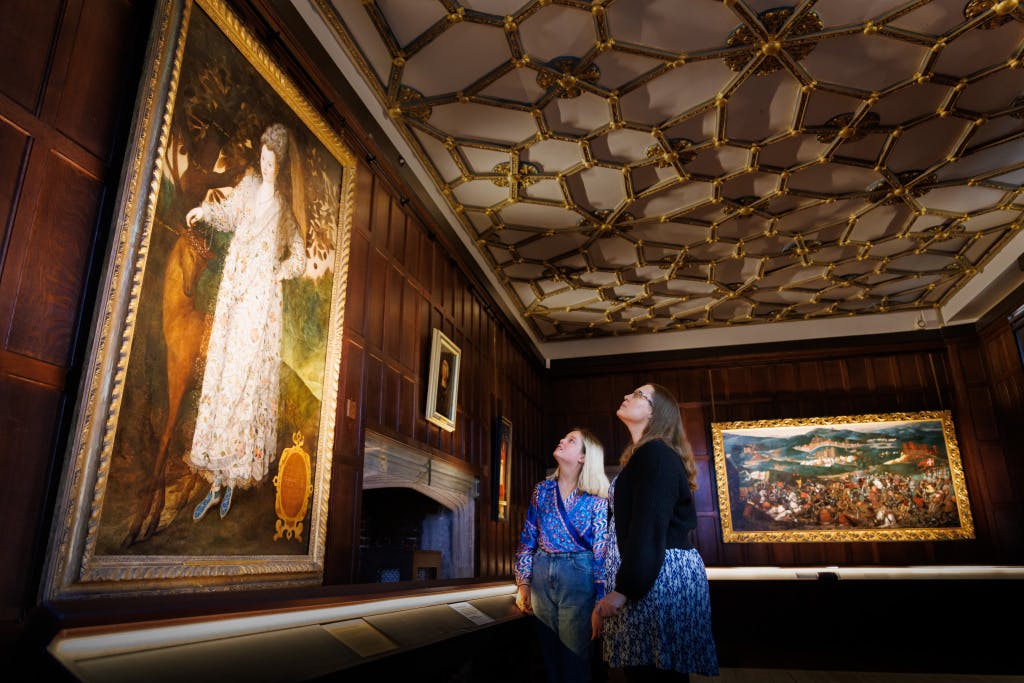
612,440,697,600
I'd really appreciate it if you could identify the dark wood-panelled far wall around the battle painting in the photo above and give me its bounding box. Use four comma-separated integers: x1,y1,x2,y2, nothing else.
545,316,1024,566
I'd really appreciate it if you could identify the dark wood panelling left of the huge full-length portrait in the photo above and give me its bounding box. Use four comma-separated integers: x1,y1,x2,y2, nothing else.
0,0,152,631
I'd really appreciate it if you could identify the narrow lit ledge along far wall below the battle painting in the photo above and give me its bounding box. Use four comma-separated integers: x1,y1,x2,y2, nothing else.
708,564,1024,581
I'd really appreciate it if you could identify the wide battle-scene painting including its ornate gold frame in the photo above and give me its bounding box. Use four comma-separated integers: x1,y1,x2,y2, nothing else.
712,411,974,543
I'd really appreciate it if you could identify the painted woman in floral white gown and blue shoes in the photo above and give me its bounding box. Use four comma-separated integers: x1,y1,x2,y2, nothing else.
185,124,305,521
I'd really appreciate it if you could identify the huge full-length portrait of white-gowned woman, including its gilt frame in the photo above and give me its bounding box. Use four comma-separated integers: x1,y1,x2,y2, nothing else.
44,0,355,599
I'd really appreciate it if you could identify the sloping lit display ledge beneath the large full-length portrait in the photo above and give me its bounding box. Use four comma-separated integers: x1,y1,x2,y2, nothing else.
47,583,521,683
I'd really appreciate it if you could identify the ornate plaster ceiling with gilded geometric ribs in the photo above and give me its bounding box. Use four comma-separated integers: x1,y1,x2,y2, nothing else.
294,0,1024,360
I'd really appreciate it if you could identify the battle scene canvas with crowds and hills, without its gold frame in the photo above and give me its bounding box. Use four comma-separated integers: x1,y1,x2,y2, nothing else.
721,419,970,532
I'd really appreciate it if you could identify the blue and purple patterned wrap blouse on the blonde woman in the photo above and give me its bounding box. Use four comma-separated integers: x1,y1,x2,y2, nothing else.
515,479,608,600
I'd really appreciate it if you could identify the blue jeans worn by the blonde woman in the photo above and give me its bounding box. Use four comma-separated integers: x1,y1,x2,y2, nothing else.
530,550,597,683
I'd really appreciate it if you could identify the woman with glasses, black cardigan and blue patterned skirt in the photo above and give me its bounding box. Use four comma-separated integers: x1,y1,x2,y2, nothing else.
591,383,718,683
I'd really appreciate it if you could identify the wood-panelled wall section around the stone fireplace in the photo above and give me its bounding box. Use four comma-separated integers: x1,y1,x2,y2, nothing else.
327,157,543,583
